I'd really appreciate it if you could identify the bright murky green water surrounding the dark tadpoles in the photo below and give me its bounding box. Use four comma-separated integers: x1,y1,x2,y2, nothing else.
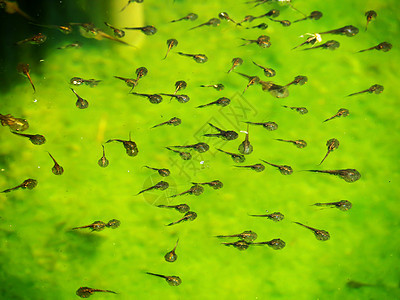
0,0,400,300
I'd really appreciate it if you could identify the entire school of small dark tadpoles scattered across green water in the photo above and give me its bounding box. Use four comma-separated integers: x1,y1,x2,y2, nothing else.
0,0,392,298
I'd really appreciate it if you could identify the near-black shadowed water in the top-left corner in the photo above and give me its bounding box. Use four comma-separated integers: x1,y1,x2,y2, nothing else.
0,0,94,92
